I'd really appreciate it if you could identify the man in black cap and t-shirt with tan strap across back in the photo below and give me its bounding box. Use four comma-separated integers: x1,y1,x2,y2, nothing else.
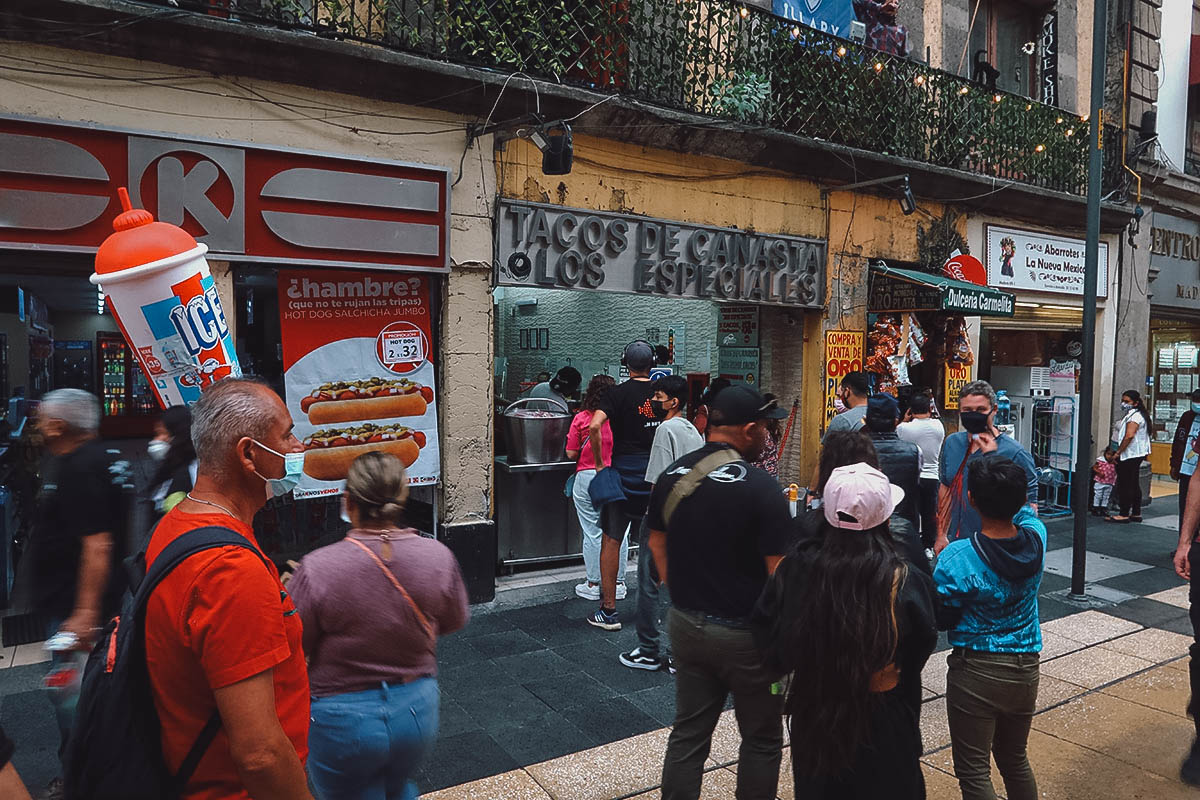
647,386,792,800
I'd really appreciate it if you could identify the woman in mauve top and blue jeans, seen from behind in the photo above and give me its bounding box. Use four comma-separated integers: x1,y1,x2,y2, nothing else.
288,452,468,800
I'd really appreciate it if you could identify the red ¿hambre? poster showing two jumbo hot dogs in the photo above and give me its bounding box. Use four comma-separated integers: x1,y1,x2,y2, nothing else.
280,270,442,498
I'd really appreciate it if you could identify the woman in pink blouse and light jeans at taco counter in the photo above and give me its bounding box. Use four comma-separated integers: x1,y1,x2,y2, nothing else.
566,375,629,600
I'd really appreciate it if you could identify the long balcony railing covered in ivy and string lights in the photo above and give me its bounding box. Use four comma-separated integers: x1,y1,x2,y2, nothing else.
157,0,1121,194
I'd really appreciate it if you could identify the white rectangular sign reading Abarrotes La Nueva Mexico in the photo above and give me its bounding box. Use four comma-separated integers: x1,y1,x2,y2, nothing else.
985,225,1109,297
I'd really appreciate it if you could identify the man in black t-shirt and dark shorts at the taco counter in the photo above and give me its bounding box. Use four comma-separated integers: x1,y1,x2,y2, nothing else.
588,339,660,631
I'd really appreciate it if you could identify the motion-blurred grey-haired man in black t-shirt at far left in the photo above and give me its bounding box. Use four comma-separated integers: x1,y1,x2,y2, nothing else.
30,389,128,767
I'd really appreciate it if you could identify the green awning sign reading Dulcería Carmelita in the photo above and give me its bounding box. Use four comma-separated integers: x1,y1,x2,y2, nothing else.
868,264,1016,317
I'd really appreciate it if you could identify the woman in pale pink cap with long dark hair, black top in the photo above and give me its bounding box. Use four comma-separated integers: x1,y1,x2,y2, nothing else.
755,464,937,800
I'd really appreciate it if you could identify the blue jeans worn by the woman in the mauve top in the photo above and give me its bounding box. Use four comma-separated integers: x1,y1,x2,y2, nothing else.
308,678,438,800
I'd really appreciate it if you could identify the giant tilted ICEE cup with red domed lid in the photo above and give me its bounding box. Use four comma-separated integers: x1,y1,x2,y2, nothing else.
91,187,241,408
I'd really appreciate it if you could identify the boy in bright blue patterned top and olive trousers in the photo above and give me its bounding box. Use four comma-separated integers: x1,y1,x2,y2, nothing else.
934,457,1046,800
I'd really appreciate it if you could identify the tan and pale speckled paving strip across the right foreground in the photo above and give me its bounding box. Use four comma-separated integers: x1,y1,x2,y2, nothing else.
425,606,1196,800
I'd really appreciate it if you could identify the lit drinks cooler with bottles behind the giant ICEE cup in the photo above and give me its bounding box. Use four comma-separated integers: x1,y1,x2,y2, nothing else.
96,332,160,439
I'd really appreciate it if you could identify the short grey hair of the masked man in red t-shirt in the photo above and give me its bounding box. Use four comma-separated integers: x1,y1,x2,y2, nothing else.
192,378,275,469
